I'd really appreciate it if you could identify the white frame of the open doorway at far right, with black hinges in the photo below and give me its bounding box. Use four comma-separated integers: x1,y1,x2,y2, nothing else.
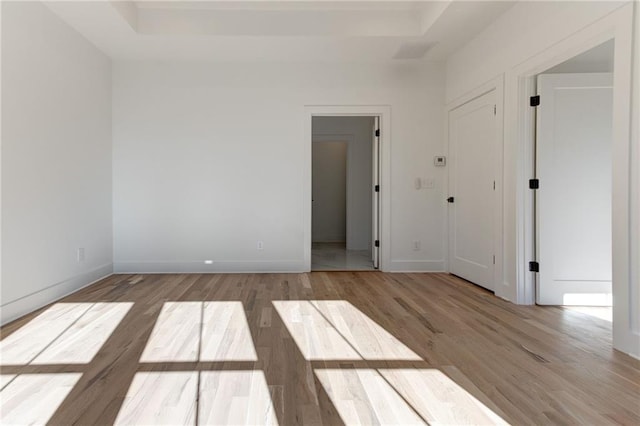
505,4,640,356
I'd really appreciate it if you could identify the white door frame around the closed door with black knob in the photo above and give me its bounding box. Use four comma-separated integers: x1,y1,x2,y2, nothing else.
442,75,504,296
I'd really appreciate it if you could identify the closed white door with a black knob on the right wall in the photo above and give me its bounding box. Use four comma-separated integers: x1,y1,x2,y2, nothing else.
448,90,498,290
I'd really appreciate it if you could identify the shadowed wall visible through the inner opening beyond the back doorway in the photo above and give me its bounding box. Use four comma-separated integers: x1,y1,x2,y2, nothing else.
311,140,349,243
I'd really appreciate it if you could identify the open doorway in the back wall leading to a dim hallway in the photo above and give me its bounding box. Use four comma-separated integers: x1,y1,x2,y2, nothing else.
311,116,379,271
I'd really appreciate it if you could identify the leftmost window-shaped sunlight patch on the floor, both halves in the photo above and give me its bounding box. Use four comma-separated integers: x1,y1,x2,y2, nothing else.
0,303,133,424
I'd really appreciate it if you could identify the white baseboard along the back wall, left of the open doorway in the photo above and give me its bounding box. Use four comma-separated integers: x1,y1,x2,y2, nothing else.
113,260,305,274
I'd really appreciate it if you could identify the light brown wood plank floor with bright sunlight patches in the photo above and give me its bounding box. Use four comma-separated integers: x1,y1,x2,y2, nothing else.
0,272,640,425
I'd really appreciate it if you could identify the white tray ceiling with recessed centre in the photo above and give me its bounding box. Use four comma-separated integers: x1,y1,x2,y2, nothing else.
46,0,514,62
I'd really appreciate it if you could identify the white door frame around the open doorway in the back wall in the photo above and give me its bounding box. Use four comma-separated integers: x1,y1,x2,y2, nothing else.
302,105,391,272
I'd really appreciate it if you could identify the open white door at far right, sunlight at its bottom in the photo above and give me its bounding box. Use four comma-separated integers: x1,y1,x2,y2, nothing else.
536,73,613,306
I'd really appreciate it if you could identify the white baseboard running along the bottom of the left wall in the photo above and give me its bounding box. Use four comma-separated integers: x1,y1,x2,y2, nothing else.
0,263,113,325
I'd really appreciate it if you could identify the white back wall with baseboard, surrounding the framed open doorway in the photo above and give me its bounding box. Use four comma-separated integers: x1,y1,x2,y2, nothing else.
113,62,444,271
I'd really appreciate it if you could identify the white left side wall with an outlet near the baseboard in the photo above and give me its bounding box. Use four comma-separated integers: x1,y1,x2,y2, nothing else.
1,2,112,323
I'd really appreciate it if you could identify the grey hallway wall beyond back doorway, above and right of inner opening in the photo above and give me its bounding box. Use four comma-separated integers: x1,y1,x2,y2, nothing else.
313,117,374,250
